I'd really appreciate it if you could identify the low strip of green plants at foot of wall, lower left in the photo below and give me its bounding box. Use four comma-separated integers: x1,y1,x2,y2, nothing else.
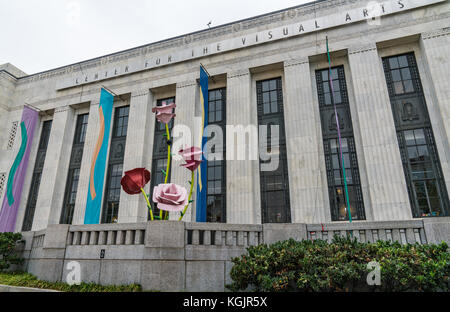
0,272,142,292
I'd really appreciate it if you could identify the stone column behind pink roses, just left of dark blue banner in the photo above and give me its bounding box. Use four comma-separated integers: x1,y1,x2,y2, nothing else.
170,79,201,222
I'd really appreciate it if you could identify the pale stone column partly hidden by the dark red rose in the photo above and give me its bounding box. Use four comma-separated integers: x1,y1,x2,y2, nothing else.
119,90,155,223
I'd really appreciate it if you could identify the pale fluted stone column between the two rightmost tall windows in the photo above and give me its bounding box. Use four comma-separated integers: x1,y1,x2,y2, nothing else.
348,44,412,221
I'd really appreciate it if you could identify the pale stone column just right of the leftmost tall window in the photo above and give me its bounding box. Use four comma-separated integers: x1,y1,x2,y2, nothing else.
32,106,75,231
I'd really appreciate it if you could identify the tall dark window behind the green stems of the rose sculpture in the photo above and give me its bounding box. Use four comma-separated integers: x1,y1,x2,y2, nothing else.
148,97,174,219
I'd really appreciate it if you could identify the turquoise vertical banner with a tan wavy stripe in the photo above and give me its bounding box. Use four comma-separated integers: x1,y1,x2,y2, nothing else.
84,88,114,224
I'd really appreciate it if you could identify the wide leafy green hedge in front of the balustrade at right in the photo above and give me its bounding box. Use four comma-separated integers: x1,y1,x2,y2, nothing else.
227,236,450,292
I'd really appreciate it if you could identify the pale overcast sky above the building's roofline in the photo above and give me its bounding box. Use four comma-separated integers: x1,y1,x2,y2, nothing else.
0,0,311,74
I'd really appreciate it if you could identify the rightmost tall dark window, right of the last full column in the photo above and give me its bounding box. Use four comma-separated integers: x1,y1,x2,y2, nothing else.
383,53,450,218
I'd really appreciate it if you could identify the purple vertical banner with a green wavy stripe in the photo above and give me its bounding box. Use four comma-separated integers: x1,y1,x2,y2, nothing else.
0,106,39,232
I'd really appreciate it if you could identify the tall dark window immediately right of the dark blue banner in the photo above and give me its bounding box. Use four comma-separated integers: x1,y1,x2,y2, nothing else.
206,88,226,223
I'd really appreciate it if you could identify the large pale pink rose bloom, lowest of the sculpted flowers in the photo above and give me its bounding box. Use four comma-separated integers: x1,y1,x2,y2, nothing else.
153,183,188,212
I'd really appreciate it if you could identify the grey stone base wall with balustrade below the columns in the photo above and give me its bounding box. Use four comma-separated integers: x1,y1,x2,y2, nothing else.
19,218,450,292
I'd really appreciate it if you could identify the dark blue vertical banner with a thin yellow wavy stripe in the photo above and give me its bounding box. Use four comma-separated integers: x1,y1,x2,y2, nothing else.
196,66,209,222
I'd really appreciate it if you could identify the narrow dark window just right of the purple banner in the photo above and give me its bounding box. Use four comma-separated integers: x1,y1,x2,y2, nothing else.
22,120,52,232
